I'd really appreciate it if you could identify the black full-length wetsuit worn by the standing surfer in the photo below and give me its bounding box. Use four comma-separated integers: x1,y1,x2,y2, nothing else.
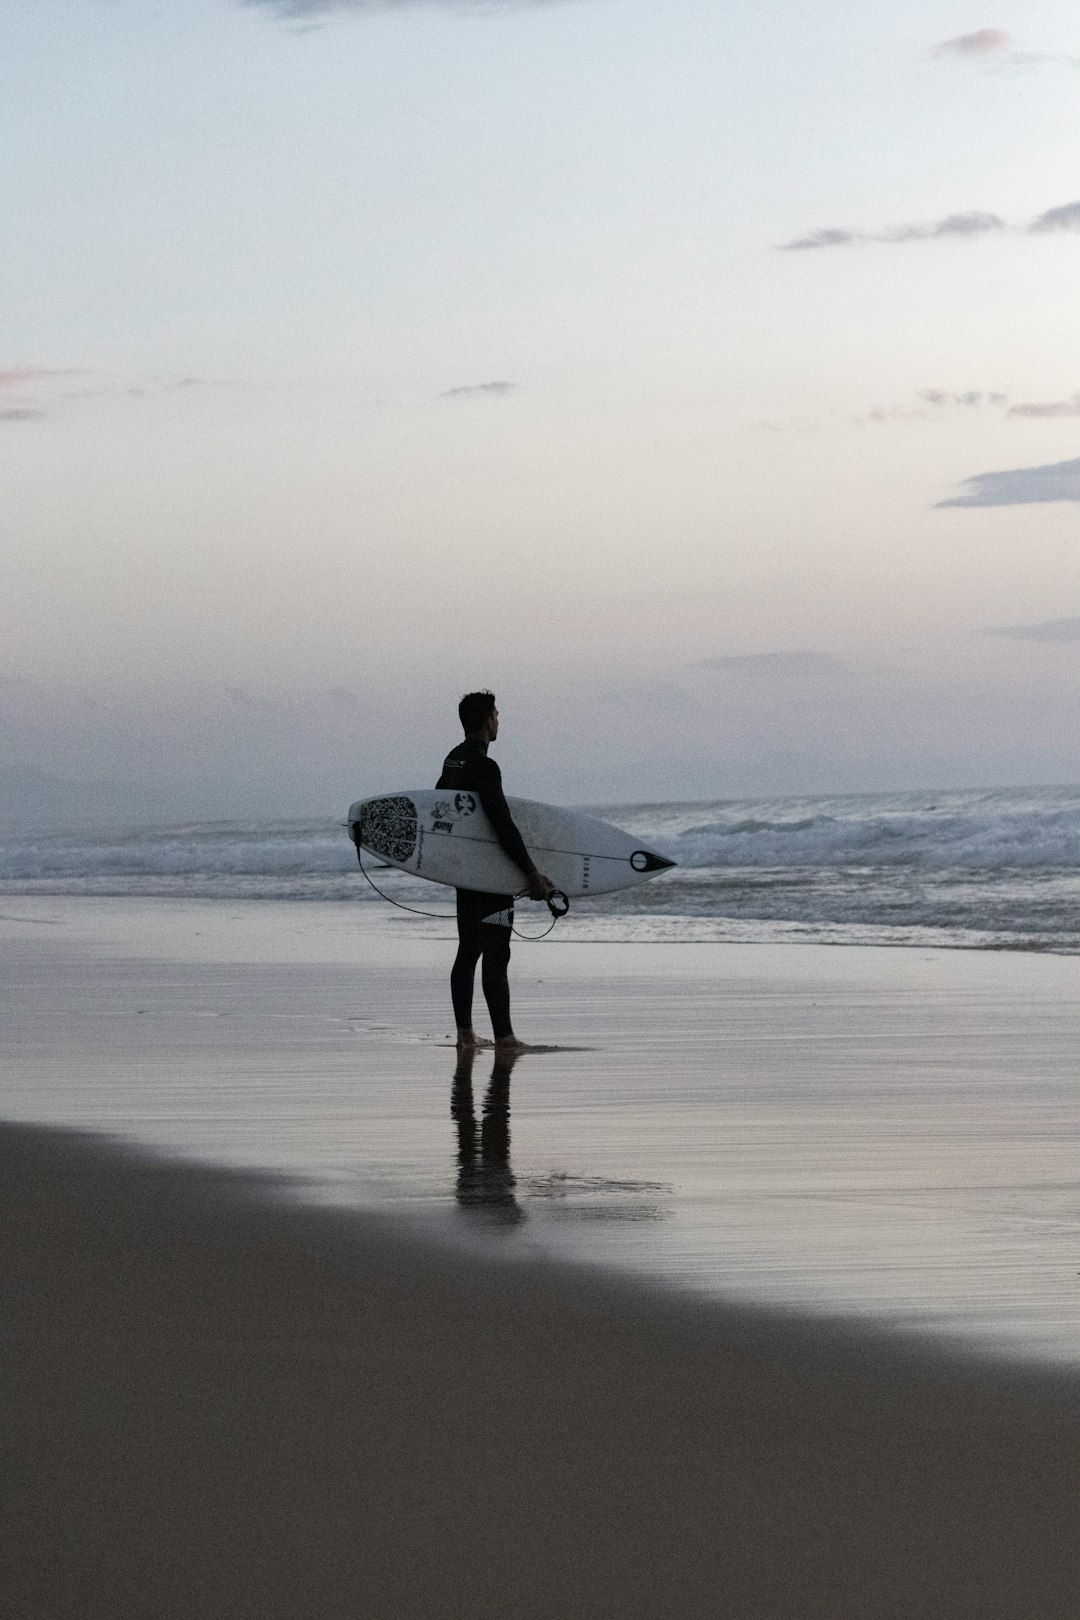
436,737,536,1040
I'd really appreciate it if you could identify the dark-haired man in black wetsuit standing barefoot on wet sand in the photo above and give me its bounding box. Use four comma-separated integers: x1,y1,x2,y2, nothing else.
436,692,554,1051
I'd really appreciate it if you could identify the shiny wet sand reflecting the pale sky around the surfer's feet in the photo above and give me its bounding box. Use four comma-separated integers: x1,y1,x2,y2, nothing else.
0,896,1080,1366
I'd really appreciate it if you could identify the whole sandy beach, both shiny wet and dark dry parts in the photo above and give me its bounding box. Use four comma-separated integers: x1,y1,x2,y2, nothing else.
0,897,1080,1620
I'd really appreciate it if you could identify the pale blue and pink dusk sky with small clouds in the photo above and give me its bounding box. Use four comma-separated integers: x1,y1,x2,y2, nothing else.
0,0,1080,815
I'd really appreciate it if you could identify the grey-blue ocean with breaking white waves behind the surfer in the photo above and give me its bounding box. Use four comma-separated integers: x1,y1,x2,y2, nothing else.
0,787,1080,954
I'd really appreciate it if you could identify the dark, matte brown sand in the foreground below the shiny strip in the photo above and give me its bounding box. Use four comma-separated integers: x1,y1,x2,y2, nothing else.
0,1126,1080,1620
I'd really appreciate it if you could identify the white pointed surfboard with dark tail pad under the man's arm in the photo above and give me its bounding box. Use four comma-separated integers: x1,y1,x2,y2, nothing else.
348,787,675,896
